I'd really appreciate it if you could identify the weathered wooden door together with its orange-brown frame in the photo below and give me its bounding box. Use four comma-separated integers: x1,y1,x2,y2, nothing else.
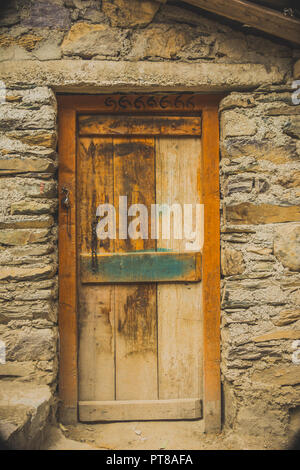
59,94,220,431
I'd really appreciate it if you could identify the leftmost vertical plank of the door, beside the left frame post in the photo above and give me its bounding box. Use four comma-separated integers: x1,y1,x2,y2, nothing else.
78,138,115,400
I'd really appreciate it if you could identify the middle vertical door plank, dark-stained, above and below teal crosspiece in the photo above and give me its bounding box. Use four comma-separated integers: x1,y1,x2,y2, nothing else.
114,137,157,400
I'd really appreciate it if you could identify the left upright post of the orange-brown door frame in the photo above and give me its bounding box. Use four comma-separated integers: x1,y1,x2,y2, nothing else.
58,103,78,422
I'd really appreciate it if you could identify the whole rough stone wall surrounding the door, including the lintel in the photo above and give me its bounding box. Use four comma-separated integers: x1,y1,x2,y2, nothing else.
0,0,300,445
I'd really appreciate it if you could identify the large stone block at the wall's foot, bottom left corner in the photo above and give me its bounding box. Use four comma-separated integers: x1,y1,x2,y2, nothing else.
0,380,53,450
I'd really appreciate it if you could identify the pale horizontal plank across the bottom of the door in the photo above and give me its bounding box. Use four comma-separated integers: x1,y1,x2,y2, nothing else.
79,398,202,422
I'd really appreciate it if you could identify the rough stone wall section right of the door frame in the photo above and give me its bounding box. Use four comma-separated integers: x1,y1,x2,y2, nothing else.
220,87,300,444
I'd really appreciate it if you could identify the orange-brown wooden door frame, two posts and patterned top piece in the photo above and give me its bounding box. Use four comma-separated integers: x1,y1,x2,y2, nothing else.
57,92,220,432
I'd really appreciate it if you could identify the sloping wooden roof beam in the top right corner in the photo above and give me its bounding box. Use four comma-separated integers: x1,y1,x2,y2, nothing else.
184,0,300,44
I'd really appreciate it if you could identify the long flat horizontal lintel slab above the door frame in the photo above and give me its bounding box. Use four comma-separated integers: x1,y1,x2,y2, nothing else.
0,59,285,93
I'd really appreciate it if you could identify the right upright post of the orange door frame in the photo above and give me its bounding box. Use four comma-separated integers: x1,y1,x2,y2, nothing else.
201,106,221,432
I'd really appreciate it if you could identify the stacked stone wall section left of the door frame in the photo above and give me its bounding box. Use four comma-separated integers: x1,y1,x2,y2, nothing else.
0,87,57,387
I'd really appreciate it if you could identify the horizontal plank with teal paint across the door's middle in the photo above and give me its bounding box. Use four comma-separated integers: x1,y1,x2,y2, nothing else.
81,251,201,283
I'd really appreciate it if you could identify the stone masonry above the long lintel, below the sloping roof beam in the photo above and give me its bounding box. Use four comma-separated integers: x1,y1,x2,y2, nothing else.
0,0,293,70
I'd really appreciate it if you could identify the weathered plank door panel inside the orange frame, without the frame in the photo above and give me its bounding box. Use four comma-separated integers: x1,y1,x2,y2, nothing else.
77,115,203,421
